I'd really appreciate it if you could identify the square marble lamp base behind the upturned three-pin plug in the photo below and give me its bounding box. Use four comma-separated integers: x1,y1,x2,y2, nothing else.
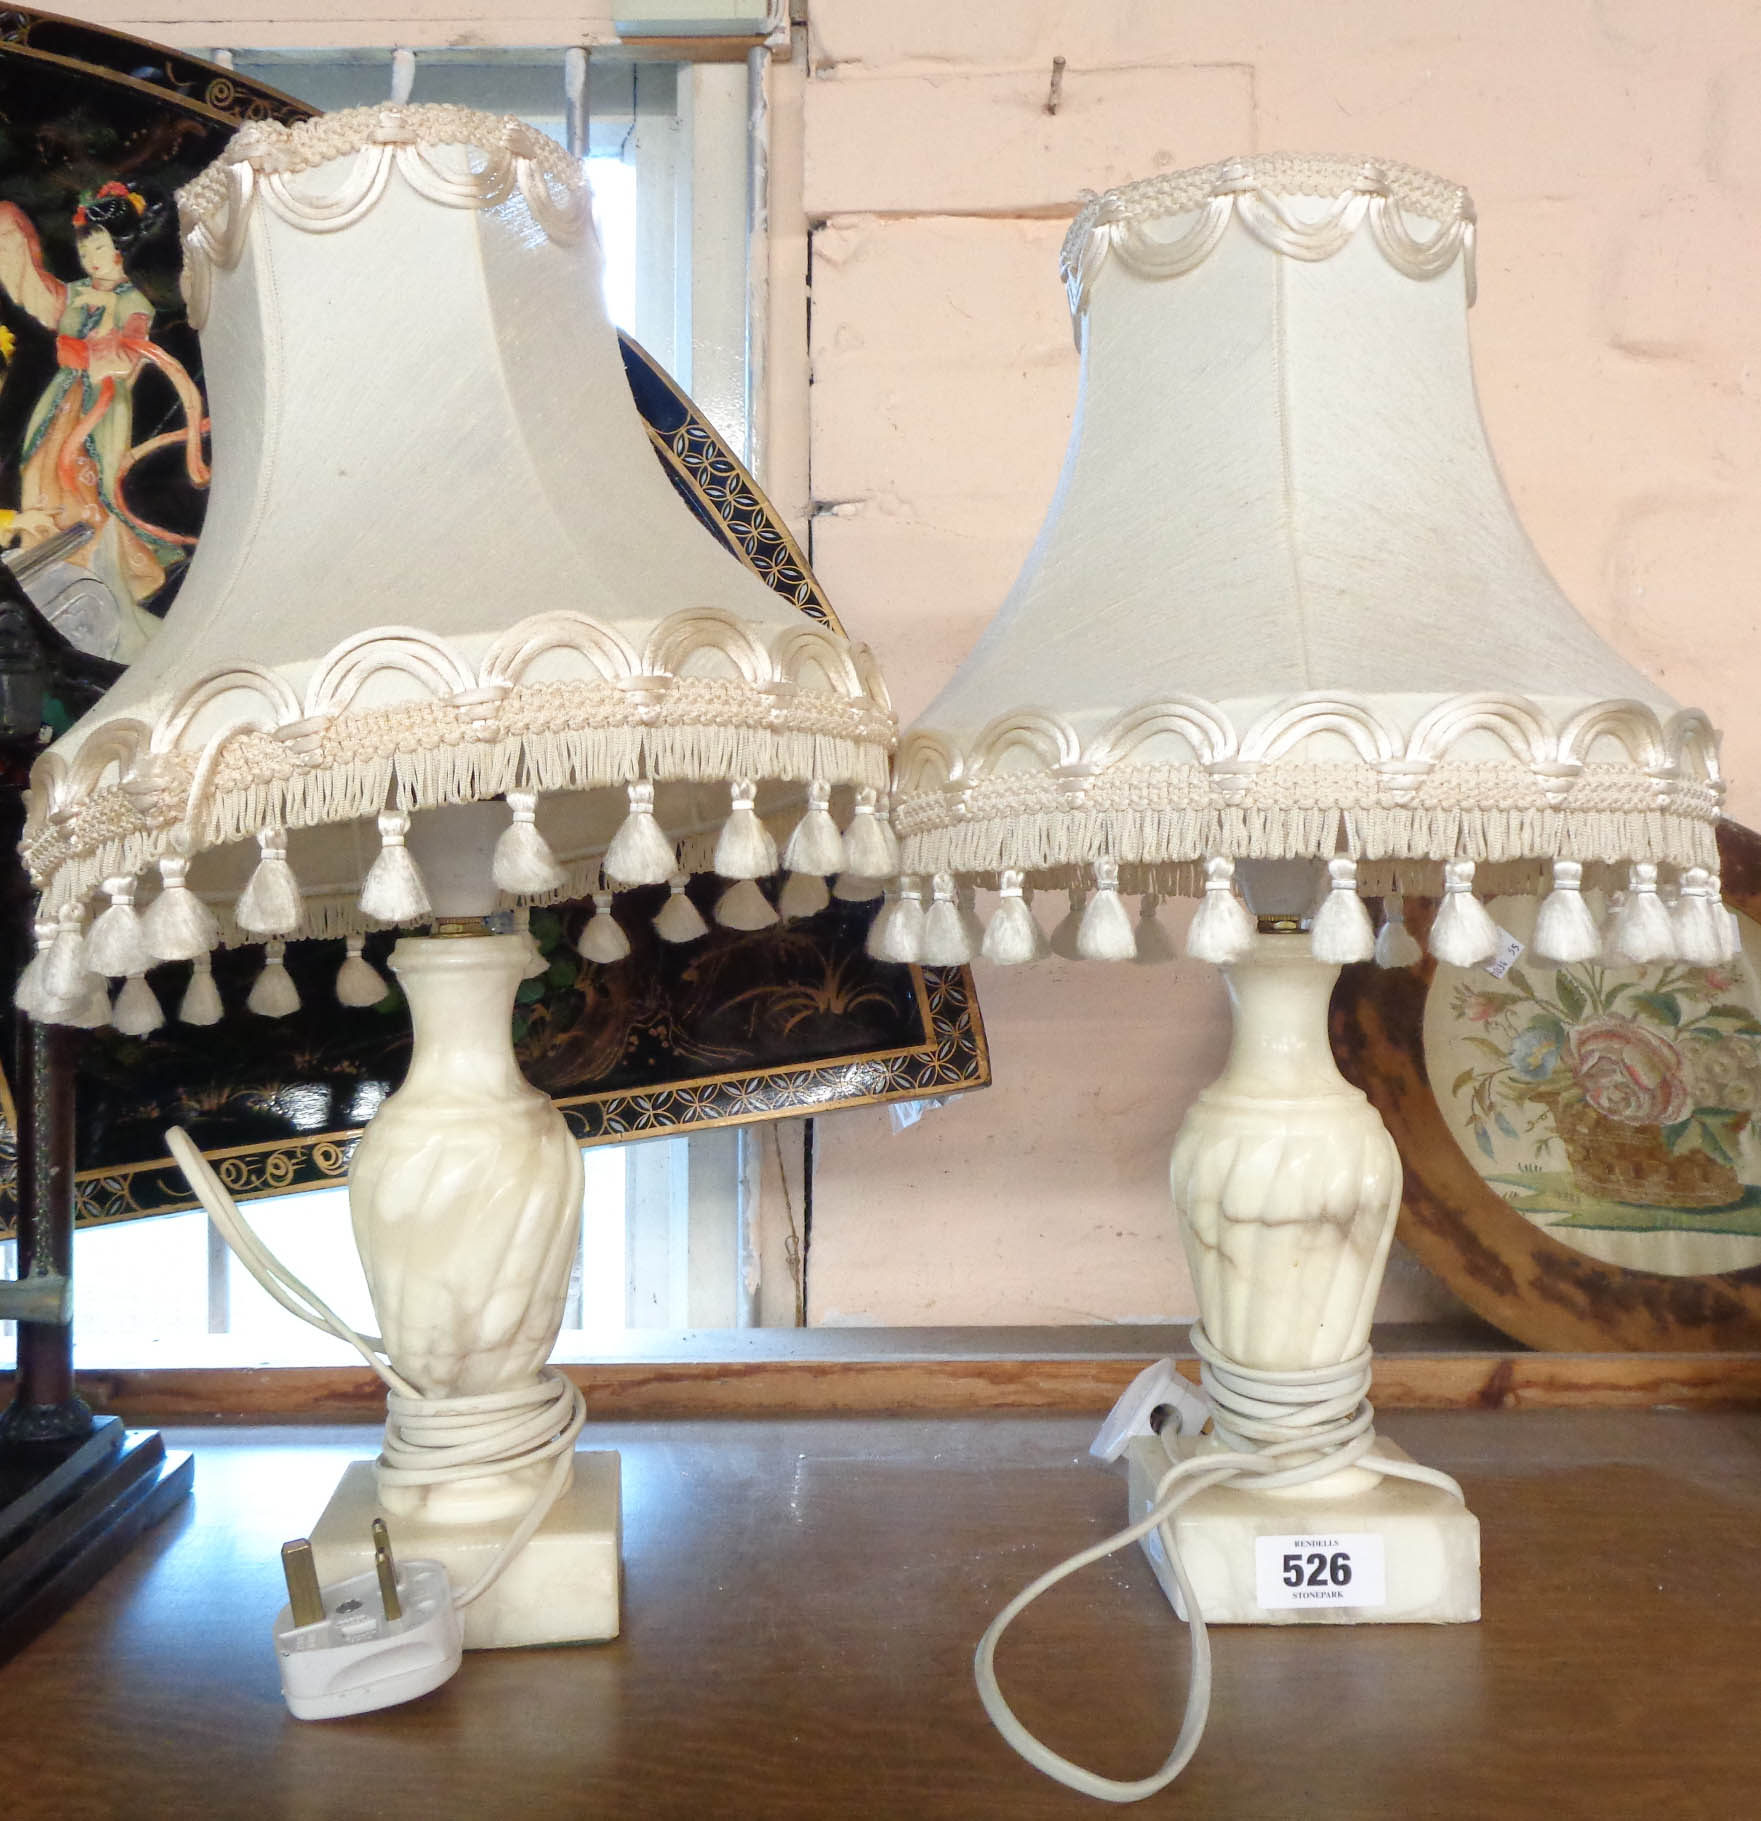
311,1450,623,1650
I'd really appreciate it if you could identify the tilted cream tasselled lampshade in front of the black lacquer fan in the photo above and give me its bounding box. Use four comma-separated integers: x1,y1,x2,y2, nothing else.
24,106,896,1022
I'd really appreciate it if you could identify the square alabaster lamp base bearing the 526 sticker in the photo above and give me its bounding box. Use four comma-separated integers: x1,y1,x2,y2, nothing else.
1125,1435,1481,1624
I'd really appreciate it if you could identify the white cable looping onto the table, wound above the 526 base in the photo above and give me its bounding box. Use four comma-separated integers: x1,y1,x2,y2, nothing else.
972,1322,1462,1803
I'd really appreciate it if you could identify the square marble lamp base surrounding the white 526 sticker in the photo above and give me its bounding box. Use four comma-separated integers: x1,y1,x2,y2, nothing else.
1125,1435,1481,1624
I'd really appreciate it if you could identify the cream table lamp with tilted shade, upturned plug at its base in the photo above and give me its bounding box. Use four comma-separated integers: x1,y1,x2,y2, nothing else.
10,106,896,1644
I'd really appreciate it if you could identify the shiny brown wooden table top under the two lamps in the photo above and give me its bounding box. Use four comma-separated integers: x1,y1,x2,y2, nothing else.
0,1411,1761,1821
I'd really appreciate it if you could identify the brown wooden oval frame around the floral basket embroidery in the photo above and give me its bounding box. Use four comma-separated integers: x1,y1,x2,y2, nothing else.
1331,821,1761,1353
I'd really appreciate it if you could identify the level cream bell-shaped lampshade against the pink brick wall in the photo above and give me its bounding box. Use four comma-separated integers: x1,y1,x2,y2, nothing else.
895,157,1730,963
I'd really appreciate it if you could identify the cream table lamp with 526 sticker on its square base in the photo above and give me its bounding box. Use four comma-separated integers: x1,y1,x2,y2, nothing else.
888,157,1732,1801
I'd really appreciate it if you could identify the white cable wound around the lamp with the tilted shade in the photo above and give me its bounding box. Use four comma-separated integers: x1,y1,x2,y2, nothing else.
166,1125,586,1606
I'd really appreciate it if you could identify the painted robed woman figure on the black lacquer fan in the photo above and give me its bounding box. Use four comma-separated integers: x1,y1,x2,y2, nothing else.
0,182,208,663
